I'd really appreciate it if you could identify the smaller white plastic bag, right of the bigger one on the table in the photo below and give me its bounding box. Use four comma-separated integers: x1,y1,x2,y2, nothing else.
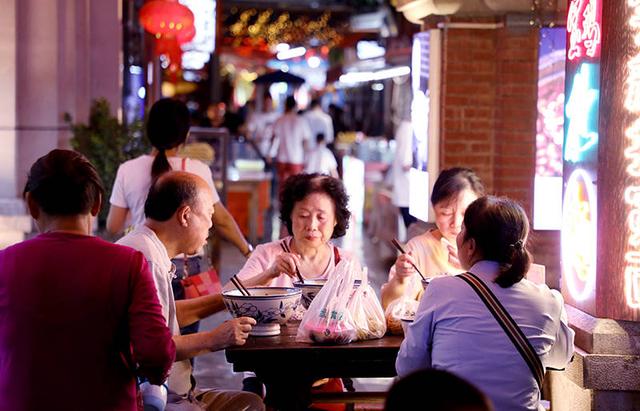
348,267,387,340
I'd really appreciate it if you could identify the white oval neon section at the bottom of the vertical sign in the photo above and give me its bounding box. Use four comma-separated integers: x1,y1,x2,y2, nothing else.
561,168,596,301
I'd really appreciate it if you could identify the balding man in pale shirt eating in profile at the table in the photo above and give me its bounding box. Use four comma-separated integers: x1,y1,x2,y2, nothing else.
118,171,264,411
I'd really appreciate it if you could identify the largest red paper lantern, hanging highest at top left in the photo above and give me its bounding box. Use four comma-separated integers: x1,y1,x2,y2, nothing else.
140,0,195,43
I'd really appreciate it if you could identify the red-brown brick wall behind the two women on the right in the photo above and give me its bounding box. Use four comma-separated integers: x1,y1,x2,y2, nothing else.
440,24,560,287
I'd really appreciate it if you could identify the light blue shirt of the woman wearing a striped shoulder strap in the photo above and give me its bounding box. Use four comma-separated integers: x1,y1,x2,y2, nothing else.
396,261,574,411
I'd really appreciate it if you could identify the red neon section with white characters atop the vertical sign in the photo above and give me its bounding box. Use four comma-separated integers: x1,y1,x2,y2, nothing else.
567,0,602,60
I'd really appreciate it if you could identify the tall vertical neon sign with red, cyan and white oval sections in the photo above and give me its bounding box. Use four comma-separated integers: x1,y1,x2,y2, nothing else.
561,0,602,303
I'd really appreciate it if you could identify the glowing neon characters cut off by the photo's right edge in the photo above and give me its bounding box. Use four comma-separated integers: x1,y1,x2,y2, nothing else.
624,0,640,308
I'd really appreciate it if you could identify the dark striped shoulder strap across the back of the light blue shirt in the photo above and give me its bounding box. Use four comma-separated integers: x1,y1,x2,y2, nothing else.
457,272,544,389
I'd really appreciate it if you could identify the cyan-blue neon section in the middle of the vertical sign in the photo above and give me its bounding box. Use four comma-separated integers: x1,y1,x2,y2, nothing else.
564,63,600,163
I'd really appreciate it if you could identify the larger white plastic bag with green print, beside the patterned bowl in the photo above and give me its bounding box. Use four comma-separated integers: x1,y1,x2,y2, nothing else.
296,260,356,344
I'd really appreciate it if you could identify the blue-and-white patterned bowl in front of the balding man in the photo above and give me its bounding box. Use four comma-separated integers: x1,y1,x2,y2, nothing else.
222,287,302,336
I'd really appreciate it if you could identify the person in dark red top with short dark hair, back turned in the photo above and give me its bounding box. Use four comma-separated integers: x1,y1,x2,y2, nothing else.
0,150,175,411
